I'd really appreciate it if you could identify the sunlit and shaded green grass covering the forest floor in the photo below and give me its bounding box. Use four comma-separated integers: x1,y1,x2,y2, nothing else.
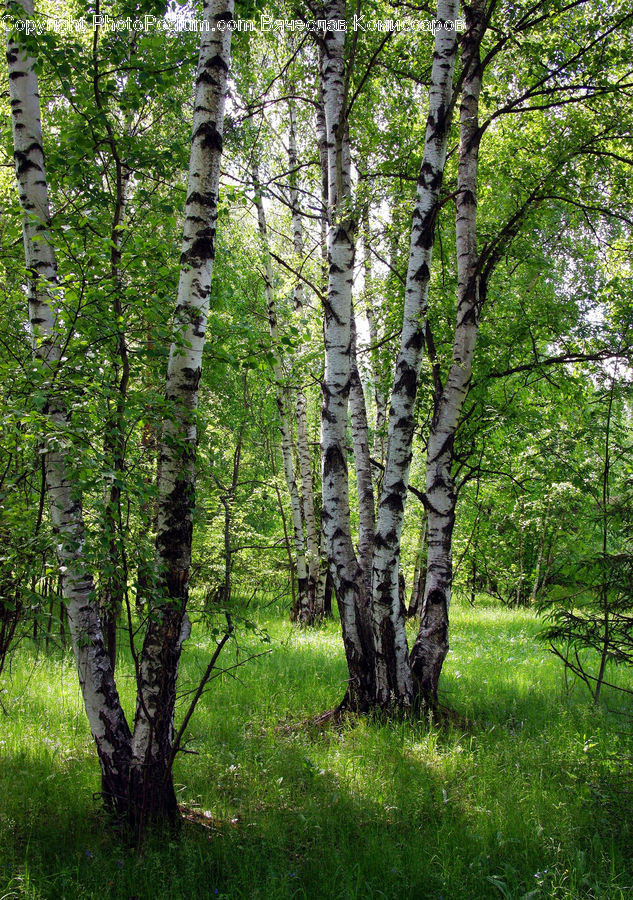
0,604,633,900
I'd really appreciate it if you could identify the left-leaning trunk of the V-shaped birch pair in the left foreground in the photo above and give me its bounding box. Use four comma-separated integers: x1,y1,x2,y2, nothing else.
7,0,131,809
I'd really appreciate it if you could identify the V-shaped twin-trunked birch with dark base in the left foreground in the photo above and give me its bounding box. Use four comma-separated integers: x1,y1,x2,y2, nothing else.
7,0,232,824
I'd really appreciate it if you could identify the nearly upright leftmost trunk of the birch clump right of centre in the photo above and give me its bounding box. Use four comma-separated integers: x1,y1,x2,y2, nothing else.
320,0,374,710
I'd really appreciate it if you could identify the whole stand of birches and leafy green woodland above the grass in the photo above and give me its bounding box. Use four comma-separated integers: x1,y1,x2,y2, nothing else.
0,0,632,828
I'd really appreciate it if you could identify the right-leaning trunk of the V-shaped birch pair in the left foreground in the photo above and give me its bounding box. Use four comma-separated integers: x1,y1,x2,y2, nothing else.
130,0,233,822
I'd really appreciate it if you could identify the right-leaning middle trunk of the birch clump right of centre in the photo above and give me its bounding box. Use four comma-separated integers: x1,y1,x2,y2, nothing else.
372,0,458,708
